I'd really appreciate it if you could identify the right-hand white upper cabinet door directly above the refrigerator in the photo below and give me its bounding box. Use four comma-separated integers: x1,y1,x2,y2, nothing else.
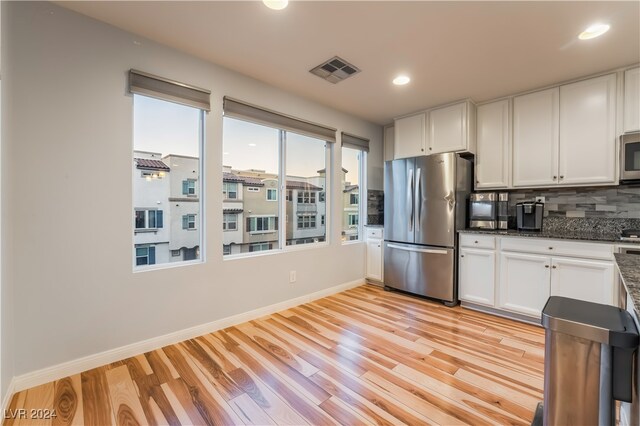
427,102,468,154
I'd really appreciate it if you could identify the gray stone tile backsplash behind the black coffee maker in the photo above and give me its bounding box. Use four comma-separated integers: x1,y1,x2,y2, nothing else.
508,185,640,219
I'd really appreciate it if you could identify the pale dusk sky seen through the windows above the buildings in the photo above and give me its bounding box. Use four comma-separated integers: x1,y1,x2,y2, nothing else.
133,95,360,184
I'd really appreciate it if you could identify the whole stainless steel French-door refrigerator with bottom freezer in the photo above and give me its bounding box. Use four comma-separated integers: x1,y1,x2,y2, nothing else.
384,153,472,306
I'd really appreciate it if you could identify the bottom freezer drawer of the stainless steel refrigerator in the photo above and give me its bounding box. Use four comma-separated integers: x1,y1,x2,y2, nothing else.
384,241,456,302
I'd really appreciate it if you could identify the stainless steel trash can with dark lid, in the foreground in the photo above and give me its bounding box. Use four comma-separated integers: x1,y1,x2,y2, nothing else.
542,296,639,426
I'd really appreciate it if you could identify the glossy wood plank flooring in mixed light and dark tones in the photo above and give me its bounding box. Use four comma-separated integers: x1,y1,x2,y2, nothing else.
4,285,544,426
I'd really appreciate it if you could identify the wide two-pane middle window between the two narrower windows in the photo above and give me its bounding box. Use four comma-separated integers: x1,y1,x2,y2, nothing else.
222,98,335,253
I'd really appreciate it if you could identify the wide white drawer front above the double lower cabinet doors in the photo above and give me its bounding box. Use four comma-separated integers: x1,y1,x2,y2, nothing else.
500,237,613,260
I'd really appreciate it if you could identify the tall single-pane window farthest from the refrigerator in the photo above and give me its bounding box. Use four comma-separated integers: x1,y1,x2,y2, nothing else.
133,89,204,268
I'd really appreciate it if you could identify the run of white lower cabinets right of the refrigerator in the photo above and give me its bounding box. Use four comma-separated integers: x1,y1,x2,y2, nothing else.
458,234,617,319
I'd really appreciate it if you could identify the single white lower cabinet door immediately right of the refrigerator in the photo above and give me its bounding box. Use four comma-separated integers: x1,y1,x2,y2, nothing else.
458,249,496,306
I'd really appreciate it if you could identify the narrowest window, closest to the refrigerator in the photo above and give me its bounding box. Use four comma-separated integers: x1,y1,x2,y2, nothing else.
342,142,368,241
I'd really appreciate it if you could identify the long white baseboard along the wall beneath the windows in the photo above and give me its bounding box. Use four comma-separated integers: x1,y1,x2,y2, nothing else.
8,279,365,397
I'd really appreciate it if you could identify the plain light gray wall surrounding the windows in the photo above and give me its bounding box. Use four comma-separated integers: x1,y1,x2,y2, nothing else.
2,2,382,386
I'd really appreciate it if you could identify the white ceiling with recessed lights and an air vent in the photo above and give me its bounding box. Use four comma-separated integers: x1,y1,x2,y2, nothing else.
57,1,640,124
